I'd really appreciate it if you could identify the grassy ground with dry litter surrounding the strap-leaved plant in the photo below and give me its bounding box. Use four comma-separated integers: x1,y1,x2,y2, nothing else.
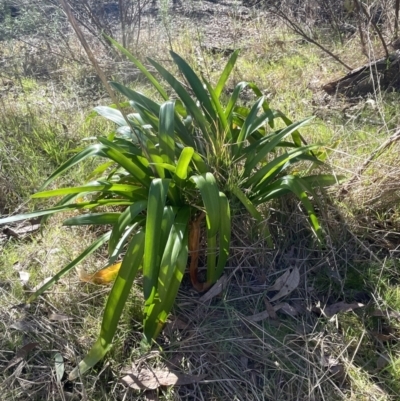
0,1,400,401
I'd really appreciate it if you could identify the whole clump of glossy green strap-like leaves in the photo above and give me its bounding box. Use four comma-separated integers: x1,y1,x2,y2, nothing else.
0,43,336,379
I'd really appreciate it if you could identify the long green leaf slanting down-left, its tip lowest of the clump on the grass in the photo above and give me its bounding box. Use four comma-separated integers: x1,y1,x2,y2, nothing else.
69,231,145,380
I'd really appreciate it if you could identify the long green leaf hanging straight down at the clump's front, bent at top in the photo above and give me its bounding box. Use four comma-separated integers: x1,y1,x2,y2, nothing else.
143,178,169,306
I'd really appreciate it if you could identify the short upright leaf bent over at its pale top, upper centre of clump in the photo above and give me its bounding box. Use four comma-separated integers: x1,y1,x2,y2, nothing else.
158,102,175,164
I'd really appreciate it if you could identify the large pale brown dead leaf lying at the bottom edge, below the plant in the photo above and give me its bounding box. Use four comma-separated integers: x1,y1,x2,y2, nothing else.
121,369,205,390
